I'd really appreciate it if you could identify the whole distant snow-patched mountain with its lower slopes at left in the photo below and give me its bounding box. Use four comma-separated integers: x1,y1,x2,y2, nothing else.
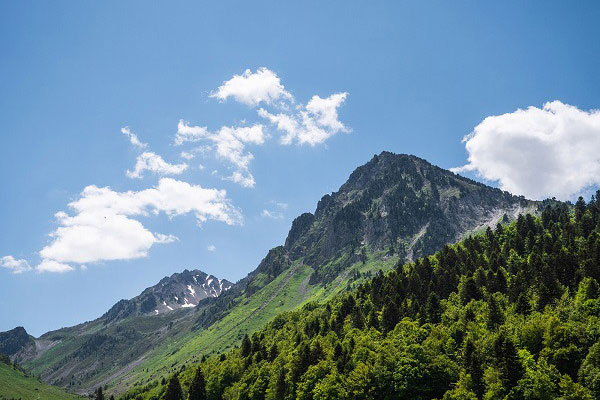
0,270,233,393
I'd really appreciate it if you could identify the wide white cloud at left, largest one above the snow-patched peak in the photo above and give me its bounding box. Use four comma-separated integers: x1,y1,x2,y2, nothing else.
37,178,241,272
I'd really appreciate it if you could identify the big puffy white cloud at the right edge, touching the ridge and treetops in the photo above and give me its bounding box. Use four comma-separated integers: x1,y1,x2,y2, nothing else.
453,101,600,200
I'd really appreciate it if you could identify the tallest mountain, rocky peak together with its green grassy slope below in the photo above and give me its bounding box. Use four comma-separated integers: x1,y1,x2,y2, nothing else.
92,152,542,392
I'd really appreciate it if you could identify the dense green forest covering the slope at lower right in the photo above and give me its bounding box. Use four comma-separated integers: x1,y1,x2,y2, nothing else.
129,192,600,400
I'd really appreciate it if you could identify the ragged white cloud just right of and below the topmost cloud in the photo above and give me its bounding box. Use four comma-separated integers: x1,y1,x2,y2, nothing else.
258,93,349,146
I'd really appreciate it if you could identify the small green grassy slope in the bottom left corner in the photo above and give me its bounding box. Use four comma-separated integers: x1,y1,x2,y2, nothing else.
0,363,83,400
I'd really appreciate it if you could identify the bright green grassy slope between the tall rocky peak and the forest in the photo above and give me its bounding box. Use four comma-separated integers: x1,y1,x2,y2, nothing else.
115,254,398,392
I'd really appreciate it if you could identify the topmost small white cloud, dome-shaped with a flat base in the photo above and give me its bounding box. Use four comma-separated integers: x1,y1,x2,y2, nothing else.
210,67,293,107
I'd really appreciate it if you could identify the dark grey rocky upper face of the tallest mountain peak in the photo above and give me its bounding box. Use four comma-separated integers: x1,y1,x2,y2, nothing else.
248,152,541,283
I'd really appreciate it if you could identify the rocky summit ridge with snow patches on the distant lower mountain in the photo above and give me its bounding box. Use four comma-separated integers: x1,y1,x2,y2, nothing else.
102,269,233,323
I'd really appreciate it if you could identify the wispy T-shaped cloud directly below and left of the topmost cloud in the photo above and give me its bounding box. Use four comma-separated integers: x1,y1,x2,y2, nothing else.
175,120,265,187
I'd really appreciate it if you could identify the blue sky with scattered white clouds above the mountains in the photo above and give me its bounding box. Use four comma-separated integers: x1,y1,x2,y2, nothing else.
0,1,600,335
